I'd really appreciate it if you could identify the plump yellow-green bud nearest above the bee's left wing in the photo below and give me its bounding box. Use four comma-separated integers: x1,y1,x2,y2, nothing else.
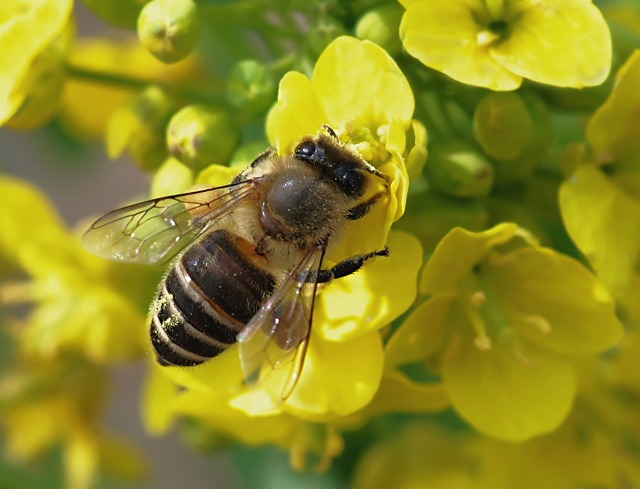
167,105,240,170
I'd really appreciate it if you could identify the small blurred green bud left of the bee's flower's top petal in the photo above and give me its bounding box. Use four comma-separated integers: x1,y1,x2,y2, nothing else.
227,59,276,114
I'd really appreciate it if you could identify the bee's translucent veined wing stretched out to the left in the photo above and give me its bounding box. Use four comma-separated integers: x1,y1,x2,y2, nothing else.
82,180,256,264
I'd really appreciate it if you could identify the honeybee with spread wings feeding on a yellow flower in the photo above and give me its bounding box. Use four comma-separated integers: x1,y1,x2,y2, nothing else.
83,126,389,399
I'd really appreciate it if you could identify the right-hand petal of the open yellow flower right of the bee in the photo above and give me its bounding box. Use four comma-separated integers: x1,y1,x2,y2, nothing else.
483,248,623,354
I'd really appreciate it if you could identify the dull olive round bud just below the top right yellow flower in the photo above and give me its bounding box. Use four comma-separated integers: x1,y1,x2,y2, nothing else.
473,92,533,160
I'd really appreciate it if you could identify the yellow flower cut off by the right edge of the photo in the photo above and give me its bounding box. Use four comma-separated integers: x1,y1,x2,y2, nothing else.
560,51,640,302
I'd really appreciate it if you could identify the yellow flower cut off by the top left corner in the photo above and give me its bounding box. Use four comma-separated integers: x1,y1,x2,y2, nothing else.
0,0,73,128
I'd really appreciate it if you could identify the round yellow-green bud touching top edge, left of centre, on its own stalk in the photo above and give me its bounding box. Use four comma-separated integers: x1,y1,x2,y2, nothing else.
138,0,200,63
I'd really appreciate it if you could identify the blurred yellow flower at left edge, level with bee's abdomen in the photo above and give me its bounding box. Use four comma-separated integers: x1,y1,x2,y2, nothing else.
0,177,158,361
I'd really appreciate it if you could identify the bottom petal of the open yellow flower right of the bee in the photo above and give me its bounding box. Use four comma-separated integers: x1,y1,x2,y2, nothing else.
442,338,576,441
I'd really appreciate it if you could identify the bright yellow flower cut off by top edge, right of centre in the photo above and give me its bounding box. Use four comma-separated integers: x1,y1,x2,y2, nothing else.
400,0,611,90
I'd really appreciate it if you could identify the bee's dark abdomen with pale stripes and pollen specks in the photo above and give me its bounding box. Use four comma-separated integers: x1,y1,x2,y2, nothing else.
151,230,275,365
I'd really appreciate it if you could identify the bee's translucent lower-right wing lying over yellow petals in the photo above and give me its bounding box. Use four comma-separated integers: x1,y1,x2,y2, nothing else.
238,246,325,401
